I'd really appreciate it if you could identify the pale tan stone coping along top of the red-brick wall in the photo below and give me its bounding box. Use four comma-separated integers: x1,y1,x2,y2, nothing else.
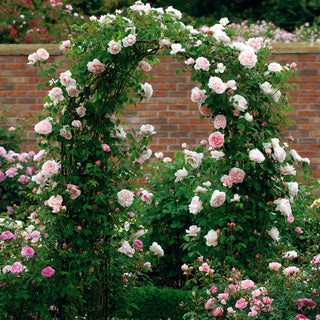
0,42,320,56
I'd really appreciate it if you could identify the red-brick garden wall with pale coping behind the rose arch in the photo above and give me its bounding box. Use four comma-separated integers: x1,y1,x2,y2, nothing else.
0,43,320,178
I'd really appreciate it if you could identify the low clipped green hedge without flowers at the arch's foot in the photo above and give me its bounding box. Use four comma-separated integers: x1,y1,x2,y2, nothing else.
116,286,192,320
